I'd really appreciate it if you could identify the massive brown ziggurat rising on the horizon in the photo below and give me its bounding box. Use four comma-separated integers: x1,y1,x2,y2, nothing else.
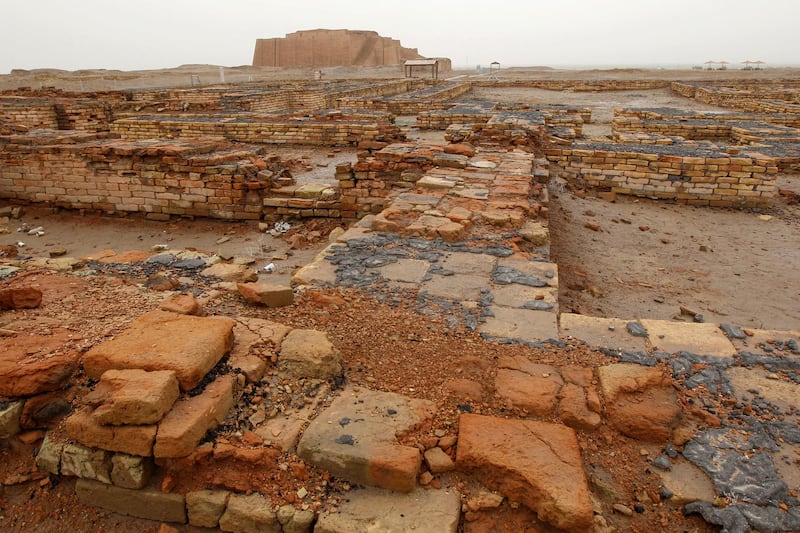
253,29,451,71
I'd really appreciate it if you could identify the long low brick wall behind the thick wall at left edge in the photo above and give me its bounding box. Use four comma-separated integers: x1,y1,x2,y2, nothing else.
112,116,402,146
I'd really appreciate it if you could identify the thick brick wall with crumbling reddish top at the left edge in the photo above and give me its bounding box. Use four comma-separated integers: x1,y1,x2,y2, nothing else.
0,136,268,219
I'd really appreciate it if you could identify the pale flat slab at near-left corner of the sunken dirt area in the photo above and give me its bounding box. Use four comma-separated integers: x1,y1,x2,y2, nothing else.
559,313,647,353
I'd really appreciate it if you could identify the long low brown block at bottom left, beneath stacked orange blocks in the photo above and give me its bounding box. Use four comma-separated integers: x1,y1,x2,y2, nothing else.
75,479,186,524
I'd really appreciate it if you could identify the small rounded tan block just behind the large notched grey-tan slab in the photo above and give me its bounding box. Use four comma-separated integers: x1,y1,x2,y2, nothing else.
278,329,342,379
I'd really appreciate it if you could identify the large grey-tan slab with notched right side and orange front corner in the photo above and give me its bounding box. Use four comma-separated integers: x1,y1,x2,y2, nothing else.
297,387,435,492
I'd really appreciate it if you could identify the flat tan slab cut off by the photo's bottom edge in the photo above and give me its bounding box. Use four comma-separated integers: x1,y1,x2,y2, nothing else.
314,488,461,533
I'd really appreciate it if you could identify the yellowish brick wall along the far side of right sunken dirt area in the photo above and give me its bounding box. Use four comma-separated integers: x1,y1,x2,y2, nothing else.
544,145,778,207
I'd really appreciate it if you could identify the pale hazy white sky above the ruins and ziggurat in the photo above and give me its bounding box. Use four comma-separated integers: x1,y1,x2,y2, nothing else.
0,0,800,73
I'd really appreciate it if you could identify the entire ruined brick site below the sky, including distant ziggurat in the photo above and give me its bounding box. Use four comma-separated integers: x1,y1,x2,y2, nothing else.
0,30,800,533
